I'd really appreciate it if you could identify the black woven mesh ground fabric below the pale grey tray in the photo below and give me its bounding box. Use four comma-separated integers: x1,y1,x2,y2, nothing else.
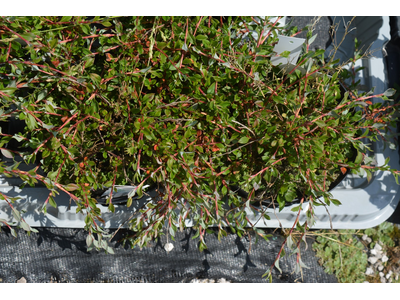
0,228,337,283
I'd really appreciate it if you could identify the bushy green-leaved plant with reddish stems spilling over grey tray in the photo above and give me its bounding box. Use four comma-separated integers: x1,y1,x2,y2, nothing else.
0,17,397,278
